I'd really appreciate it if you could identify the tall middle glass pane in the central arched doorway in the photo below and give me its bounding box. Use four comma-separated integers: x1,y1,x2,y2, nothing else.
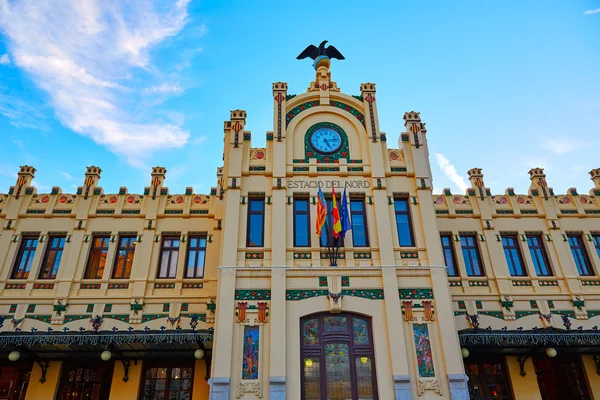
325,343,352,400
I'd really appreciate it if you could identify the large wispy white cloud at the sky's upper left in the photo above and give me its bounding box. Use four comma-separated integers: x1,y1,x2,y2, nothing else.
0,0,189,166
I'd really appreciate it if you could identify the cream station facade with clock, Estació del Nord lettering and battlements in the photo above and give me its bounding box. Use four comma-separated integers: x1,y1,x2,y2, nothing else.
0,59,600,400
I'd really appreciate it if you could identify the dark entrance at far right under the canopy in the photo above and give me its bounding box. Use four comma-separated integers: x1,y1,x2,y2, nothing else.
533,356,590,400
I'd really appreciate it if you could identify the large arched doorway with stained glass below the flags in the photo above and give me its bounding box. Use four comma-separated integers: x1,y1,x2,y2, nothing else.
300,313,378,400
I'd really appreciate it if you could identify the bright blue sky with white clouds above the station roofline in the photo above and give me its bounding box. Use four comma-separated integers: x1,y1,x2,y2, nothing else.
0,0,600,193
